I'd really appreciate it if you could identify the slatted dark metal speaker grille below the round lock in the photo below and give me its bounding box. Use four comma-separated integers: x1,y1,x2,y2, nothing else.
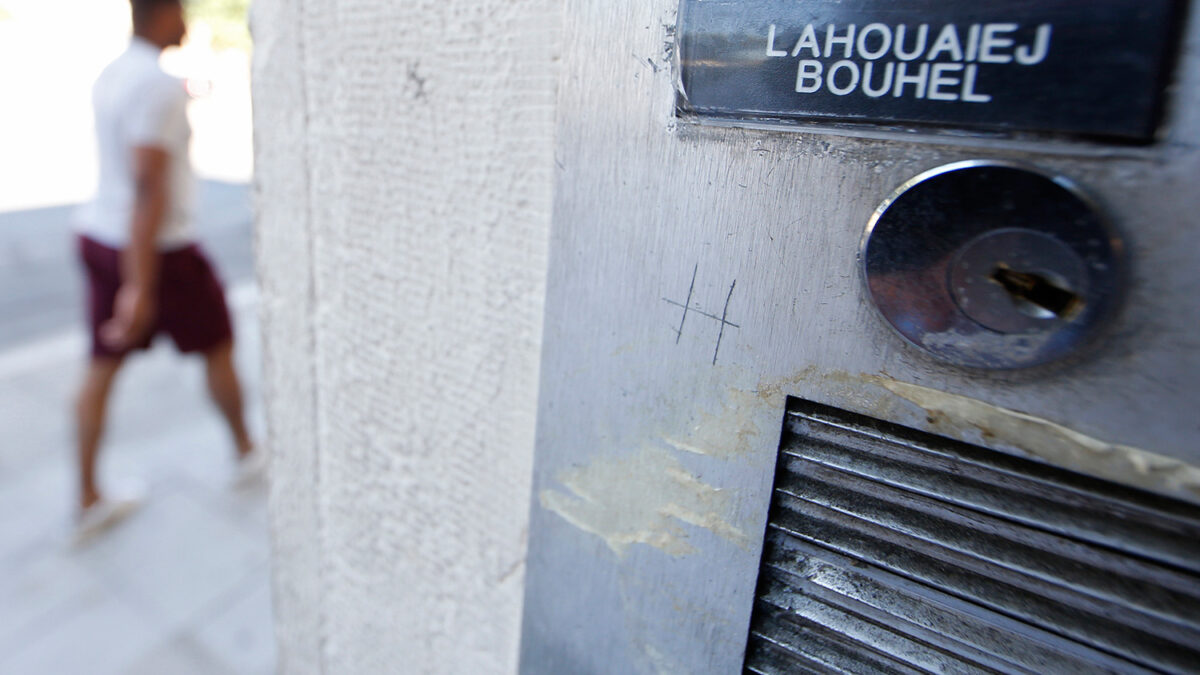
745,399,1200,675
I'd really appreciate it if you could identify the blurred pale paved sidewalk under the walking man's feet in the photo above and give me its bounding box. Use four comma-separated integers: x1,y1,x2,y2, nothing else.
0,283,275,675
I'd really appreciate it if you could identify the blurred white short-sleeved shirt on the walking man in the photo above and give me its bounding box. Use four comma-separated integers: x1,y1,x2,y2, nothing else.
77,37,194,250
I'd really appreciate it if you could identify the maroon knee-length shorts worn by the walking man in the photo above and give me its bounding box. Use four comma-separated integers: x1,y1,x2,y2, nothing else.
79,237,233,357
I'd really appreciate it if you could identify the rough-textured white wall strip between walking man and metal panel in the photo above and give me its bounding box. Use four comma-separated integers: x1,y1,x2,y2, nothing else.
252,0,559,674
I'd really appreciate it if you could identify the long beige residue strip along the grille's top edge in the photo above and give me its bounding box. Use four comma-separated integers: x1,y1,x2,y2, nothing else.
876,378,1200,502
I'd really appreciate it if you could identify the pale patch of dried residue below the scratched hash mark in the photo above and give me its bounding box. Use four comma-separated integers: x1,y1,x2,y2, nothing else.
539,448,746,556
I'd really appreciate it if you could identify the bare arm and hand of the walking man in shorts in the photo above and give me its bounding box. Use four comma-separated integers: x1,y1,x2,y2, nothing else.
101,147,170,348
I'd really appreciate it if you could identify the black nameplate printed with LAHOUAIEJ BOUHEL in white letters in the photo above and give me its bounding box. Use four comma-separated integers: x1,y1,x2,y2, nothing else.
678,0,1183,141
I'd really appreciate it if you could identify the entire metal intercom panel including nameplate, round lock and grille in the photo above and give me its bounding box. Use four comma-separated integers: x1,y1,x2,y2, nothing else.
522,0,1200,674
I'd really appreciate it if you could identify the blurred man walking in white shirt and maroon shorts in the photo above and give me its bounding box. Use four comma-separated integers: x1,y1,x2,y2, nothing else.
76,0,263,539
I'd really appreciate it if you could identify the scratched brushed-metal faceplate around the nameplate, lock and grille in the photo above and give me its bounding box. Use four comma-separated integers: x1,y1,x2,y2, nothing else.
522,0,1200,673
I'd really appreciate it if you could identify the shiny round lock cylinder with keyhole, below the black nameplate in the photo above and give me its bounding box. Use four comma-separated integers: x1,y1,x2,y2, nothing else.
860,161,1124,369
